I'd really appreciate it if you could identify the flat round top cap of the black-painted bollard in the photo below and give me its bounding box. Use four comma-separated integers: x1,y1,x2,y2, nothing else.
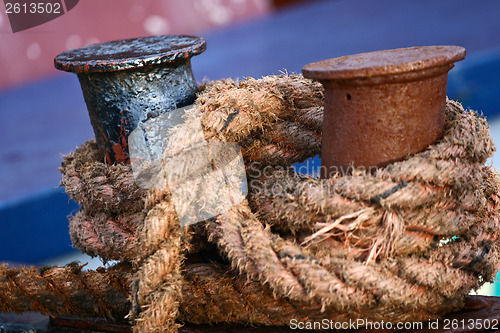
54,35,206,73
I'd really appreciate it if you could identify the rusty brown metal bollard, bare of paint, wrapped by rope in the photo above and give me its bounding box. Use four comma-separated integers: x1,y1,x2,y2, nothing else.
302,46,465,178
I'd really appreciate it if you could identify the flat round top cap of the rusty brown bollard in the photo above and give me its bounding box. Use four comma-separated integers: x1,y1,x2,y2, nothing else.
302,45,465,81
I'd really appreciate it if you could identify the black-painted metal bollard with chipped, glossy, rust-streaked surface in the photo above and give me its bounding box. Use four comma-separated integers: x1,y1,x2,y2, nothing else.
54,35,206,163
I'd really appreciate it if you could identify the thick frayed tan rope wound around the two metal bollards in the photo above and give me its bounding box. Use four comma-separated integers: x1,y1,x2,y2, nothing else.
0,75,499,332
